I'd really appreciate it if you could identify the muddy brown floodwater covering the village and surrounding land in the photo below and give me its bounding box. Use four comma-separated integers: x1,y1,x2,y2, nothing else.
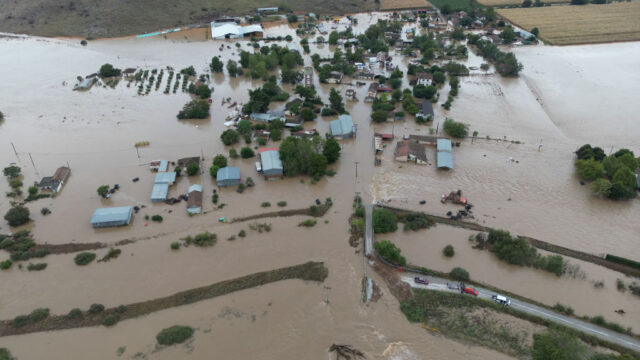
0,14,640,360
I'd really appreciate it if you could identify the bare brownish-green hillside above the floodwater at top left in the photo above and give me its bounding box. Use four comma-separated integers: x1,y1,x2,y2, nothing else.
0,0,376,38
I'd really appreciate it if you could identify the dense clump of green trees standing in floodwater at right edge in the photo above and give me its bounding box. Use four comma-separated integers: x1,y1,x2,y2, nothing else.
575,144,640,200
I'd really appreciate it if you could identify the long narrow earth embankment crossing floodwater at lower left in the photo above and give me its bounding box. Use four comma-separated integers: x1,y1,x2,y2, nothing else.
0,261,329,337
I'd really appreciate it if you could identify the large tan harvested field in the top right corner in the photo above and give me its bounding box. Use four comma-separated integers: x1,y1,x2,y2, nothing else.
498,2,640,45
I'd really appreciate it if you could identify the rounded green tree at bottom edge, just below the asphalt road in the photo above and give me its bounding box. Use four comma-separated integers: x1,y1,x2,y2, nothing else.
532,330,586,360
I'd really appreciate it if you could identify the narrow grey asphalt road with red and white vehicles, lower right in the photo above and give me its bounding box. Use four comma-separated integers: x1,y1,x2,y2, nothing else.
401,275,640,351
